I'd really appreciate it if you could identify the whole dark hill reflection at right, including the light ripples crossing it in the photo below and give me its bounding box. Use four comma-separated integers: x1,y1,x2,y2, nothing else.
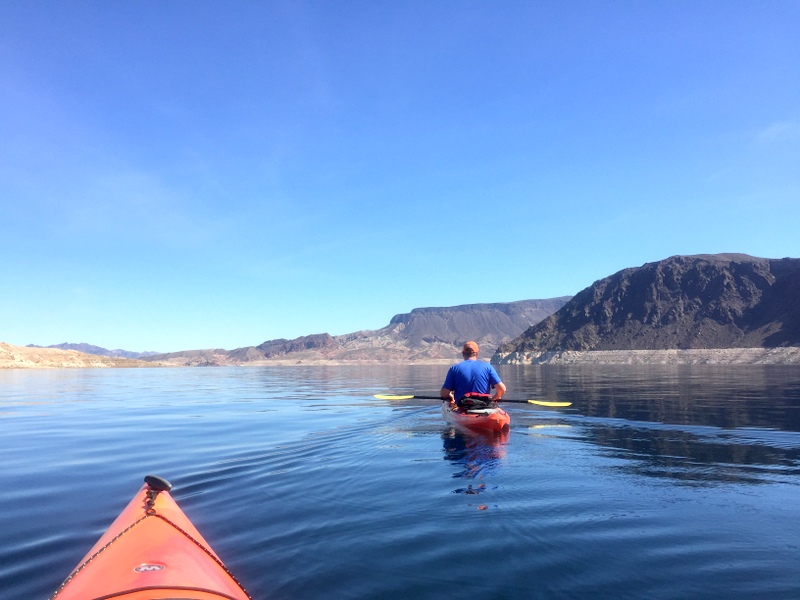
503,365,800,485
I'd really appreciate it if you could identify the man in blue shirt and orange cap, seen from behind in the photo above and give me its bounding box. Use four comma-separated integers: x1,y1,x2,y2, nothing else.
439,341,506,407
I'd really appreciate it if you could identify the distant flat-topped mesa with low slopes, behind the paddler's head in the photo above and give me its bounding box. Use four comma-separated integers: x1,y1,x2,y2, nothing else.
143,296,569,366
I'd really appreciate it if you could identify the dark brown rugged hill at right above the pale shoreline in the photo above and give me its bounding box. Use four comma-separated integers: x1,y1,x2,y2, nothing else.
492,254,800,364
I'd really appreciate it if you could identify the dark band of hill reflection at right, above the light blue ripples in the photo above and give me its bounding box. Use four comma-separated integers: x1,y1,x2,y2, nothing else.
502,365,800,432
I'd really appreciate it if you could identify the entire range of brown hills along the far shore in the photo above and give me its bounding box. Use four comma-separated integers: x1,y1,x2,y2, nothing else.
17,253,800,367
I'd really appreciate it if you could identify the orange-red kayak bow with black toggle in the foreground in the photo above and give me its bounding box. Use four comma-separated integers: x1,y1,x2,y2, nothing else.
50,475,251,600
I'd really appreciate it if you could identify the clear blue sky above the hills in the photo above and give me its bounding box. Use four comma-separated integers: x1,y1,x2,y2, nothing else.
0,0,800,351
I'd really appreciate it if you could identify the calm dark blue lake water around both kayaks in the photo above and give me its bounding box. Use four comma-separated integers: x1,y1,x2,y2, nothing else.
0,366,800,600
